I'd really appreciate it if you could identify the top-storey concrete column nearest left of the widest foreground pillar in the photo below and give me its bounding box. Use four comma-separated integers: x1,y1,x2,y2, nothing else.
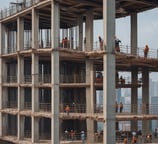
85,10,93,51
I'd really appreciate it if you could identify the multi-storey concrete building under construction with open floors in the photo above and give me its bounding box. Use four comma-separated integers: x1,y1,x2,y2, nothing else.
0,0,158,144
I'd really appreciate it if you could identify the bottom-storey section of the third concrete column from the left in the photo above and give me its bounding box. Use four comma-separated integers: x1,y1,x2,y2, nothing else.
32,117,39,143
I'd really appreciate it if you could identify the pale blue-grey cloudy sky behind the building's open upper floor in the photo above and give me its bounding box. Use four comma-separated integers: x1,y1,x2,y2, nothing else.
0,0,158,81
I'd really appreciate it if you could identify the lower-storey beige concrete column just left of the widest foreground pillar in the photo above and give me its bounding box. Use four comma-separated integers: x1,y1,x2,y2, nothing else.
86,60,95,143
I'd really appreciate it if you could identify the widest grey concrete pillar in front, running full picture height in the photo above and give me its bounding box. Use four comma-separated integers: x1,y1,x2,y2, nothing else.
103,0,115,144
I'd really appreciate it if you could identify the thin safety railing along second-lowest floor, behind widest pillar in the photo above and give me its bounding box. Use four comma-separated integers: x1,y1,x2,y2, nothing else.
60,103,158,115
